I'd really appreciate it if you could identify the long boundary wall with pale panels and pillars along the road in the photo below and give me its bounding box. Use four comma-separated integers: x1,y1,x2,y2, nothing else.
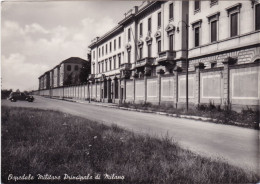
34,62,260,109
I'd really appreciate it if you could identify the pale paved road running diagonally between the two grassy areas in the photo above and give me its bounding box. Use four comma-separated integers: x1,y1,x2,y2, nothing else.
2,97,260,173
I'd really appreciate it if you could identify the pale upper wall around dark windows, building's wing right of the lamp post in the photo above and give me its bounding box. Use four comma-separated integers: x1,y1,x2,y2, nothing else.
189,1,260,57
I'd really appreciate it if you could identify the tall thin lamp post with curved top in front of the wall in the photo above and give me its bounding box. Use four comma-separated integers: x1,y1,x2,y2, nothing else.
177,19,190,111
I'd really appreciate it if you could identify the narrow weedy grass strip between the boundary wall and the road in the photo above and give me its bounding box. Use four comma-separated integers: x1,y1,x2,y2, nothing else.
119,102,260,130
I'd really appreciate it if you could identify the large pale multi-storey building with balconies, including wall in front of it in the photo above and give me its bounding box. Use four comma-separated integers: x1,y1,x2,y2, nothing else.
89,0,260,107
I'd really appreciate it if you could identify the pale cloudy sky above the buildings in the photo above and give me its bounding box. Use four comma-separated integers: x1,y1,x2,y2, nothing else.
1,0,141,91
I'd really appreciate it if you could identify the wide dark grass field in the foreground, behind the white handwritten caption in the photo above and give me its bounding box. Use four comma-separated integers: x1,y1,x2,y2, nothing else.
1,106,259,184
